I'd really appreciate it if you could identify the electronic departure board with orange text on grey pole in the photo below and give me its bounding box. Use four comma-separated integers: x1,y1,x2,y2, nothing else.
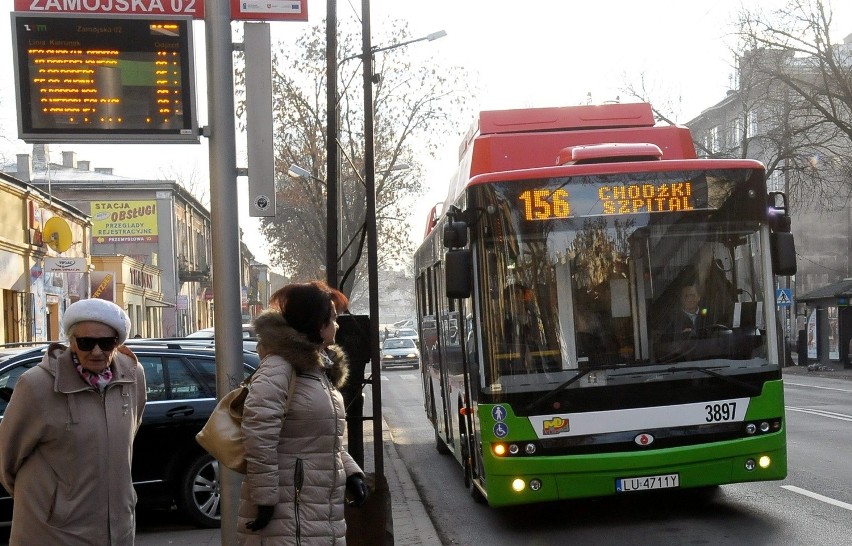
12,12,199,143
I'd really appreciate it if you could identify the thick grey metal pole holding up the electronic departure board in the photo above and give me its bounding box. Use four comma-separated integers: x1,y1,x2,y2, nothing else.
204,0,243,546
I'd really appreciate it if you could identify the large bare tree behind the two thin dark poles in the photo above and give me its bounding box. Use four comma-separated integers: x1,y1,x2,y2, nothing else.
237,21,470,294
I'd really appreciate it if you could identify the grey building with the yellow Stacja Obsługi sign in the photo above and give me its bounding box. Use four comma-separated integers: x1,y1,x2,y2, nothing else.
4,145,269,337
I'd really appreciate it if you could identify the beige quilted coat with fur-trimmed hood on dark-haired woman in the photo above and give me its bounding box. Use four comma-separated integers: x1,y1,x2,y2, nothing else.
237,312,361,546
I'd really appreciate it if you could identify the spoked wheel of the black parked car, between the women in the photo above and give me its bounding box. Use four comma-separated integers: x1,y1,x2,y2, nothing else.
177,453,222,528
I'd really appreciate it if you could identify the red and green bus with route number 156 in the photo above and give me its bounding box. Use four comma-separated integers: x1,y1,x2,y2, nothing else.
415,104,796,506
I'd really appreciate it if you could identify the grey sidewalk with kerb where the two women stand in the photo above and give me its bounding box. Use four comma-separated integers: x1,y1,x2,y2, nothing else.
136,412,441,546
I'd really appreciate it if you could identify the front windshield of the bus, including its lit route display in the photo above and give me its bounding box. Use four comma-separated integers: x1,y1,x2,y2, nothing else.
468,169,779,393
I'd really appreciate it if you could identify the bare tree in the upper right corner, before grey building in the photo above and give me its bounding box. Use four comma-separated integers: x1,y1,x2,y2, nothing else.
737,0,852,204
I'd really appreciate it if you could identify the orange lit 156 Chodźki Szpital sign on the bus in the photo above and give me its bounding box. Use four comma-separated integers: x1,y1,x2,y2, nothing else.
518,181,696,220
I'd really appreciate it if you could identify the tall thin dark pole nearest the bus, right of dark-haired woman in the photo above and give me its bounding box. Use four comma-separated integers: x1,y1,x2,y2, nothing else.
361,0,385,477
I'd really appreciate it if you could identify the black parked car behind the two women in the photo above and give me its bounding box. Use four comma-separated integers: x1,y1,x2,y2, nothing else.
0,339,260,527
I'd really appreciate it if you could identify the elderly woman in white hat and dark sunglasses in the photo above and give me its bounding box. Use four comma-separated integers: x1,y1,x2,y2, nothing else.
0,299,145,546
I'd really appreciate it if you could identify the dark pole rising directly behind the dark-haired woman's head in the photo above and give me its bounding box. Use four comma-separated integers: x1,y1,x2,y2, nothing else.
325,0,343,288
